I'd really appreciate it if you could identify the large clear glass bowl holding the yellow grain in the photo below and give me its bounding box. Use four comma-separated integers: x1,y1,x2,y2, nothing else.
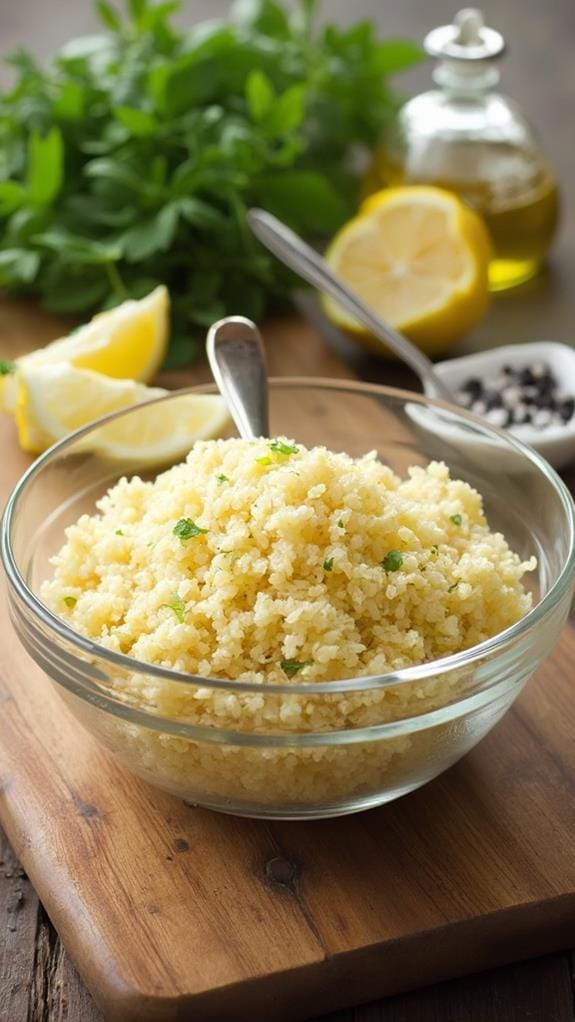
2,379,574,819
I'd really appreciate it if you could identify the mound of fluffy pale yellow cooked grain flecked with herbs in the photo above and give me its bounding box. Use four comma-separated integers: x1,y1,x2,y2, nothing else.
42,438,535,813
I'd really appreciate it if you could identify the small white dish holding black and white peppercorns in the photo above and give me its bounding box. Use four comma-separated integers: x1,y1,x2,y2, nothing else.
425,340,575,468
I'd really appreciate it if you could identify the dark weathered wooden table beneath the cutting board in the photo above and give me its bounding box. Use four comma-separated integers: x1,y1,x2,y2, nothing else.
0,0,575,1022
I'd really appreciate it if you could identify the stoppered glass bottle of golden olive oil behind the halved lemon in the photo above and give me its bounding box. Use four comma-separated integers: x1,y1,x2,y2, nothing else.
365,8,560,291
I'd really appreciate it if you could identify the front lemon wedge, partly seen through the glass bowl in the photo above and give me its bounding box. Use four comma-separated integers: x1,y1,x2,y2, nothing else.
16,362,229,461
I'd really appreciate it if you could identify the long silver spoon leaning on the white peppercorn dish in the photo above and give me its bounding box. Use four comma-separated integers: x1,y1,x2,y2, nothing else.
247,210,454,402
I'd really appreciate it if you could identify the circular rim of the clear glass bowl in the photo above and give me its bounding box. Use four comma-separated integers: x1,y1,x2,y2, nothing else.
0,376,575,696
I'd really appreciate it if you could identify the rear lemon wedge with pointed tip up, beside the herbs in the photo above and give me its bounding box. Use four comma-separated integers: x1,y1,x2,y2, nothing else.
0,285,170,413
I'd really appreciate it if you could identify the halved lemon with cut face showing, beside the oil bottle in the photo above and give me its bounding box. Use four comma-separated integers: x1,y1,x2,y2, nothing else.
323,185,490,355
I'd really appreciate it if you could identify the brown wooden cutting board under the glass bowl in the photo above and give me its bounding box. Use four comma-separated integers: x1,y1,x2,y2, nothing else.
0,307,575,1022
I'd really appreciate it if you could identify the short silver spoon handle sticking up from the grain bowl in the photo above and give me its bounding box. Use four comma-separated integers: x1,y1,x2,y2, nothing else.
205,316,270,439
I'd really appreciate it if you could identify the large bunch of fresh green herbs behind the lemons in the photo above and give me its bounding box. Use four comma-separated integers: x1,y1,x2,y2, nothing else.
0,0,422,367
